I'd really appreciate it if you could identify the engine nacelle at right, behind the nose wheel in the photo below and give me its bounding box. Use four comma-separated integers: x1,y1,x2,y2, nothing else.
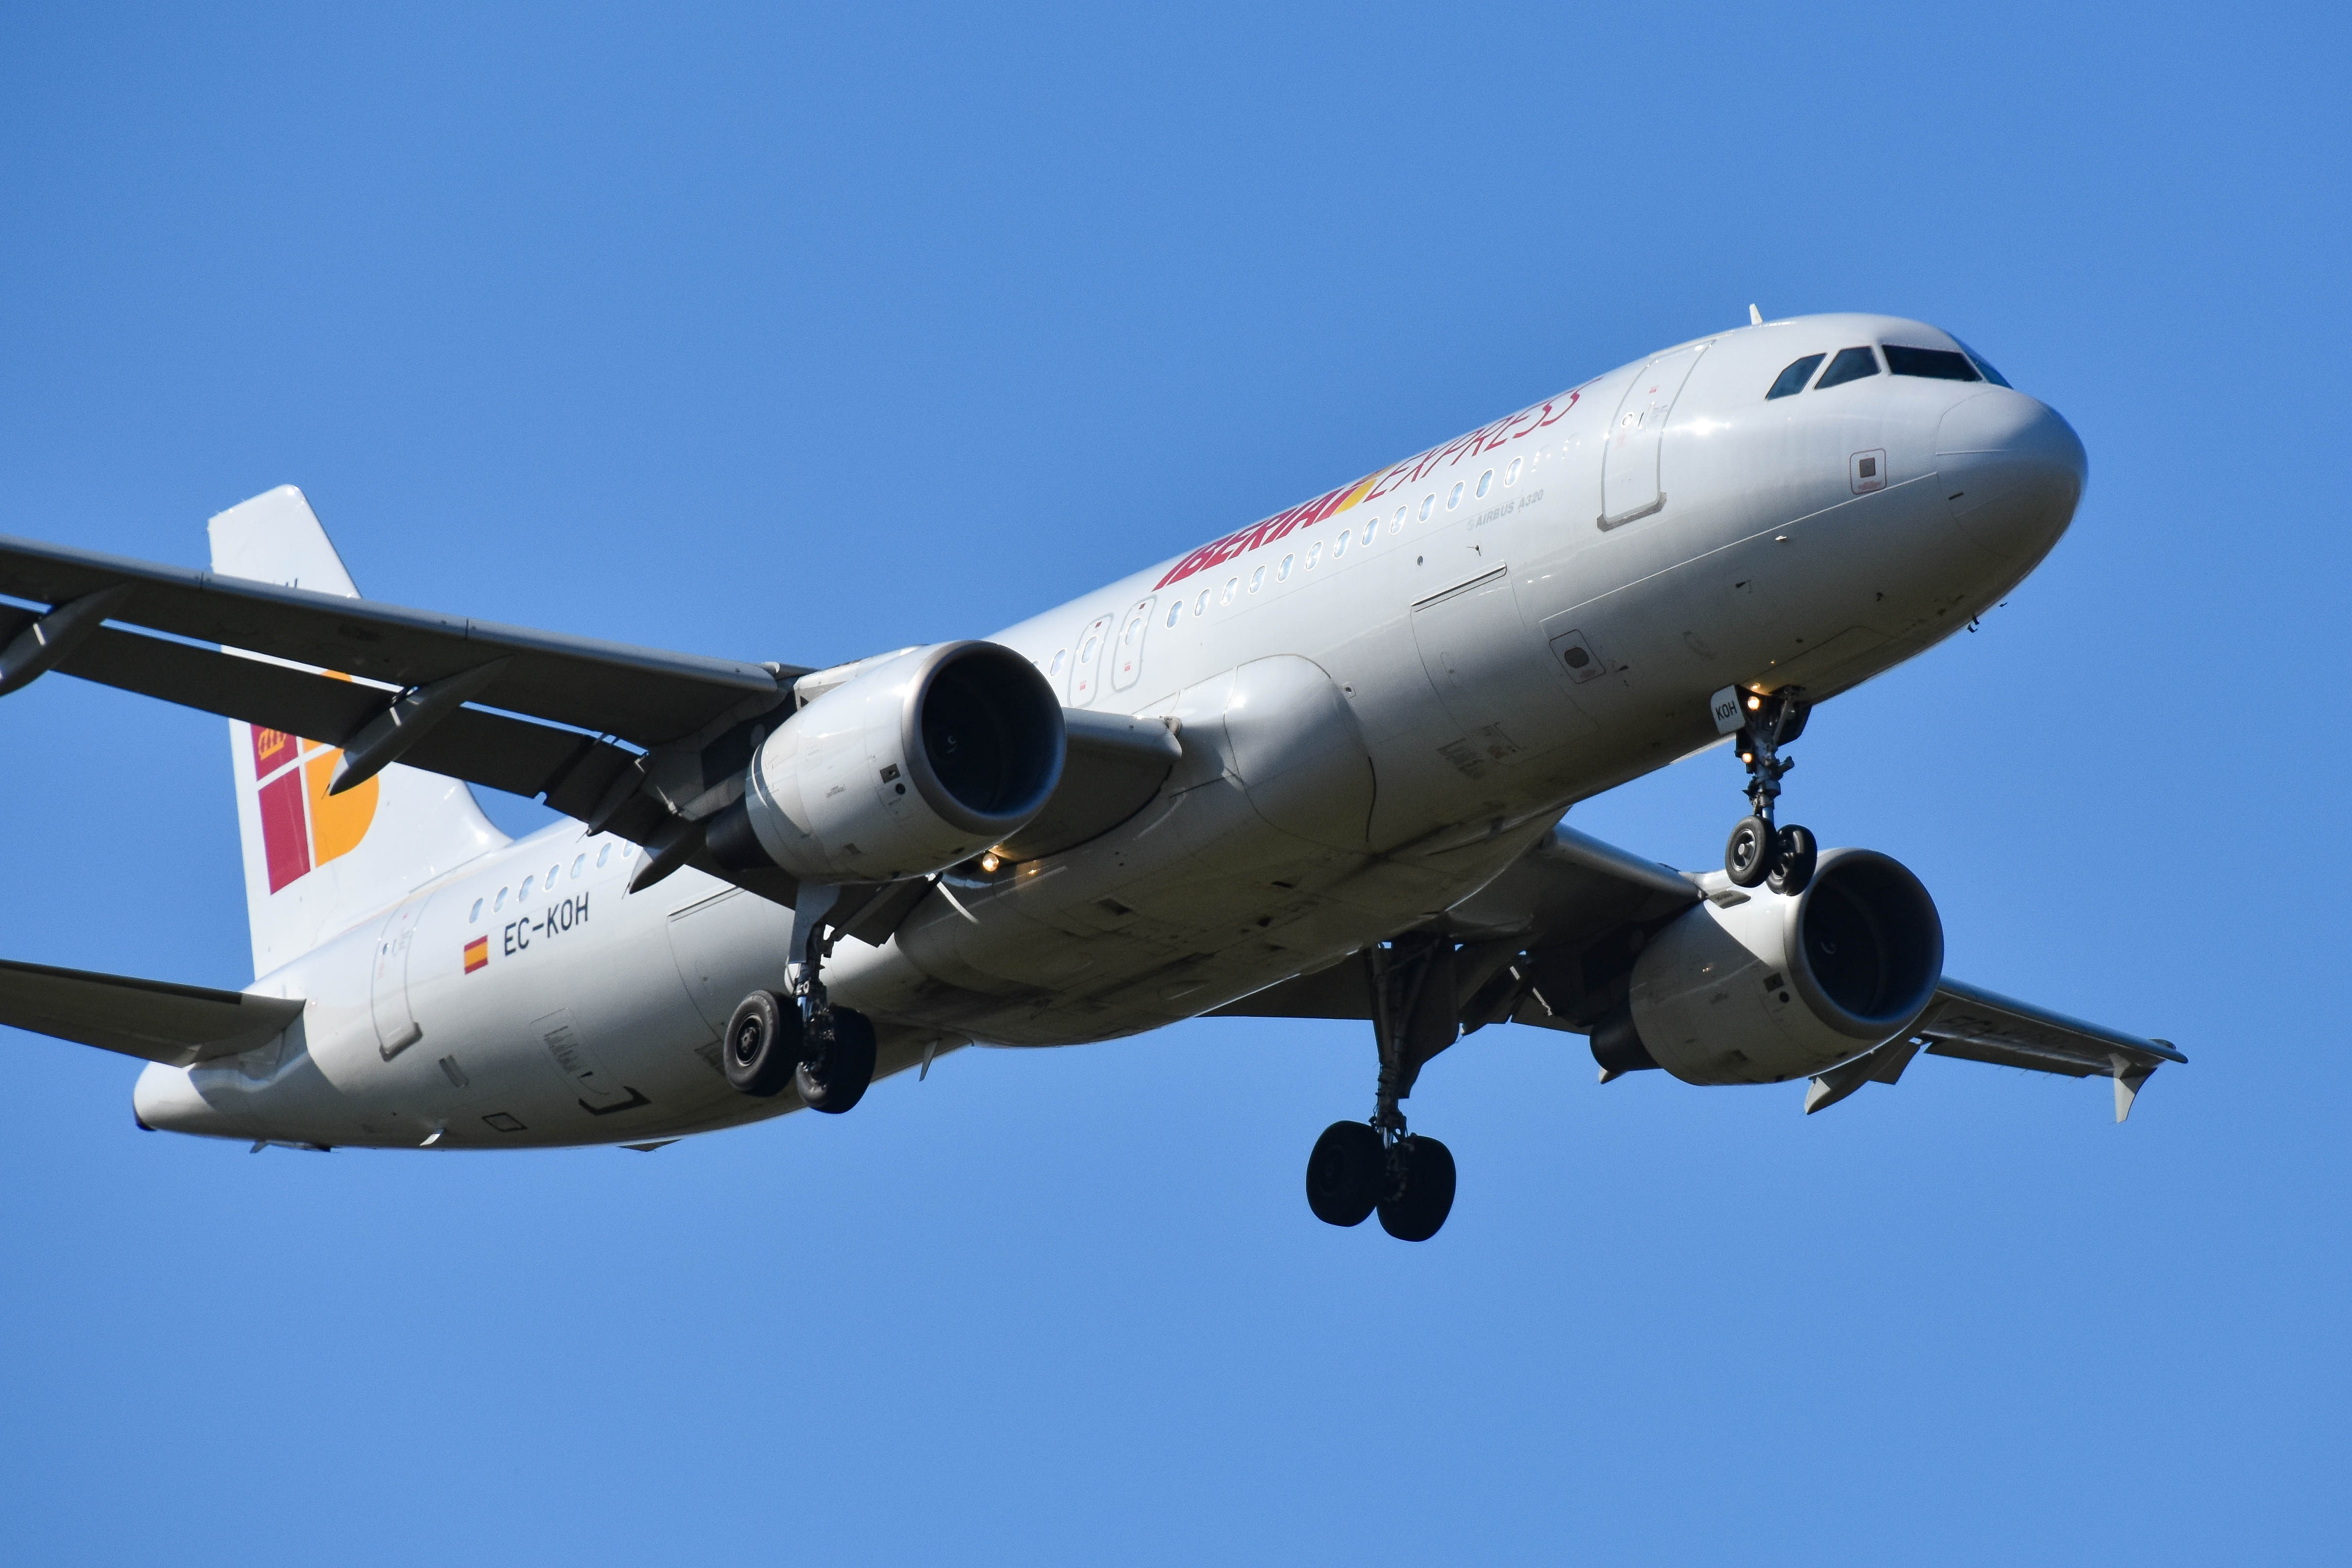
1627,849,1943,1084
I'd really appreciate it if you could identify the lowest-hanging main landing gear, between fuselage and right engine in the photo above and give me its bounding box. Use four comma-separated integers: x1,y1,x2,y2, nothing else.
1307,938,1461,1241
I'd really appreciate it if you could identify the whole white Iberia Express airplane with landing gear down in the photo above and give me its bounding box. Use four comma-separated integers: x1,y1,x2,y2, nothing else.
0,306,2185,1241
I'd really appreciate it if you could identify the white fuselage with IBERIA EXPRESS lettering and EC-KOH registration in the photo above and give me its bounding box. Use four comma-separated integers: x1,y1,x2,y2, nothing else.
136,315,2082,1147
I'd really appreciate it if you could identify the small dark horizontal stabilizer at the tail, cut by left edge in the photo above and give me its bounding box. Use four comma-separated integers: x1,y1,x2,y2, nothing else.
0,959,303,1067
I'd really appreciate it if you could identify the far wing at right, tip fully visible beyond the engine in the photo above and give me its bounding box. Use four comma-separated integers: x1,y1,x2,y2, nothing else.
1216,823,2188,1121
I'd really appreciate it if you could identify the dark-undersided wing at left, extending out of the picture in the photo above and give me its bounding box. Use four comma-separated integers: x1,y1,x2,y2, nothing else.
0,524,807,839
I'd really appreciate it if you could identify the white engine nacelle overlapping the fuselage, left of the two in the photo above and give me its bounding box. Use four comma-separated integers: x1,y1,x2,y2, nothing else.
703,642,1066,882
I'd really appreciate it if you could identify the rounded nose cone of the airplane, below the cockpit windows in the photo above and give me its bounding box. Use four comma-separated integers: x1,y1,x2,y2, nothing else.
1936,388,2091,559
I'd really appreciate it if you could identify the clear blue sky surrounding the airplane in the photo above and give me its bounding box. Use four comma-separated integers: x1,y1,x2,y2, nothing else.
0,5,2352,1568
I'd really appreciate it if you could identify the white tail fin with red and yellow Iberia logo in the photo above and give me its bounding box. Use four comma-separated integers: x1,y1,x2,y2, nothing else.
212,484,506,976
